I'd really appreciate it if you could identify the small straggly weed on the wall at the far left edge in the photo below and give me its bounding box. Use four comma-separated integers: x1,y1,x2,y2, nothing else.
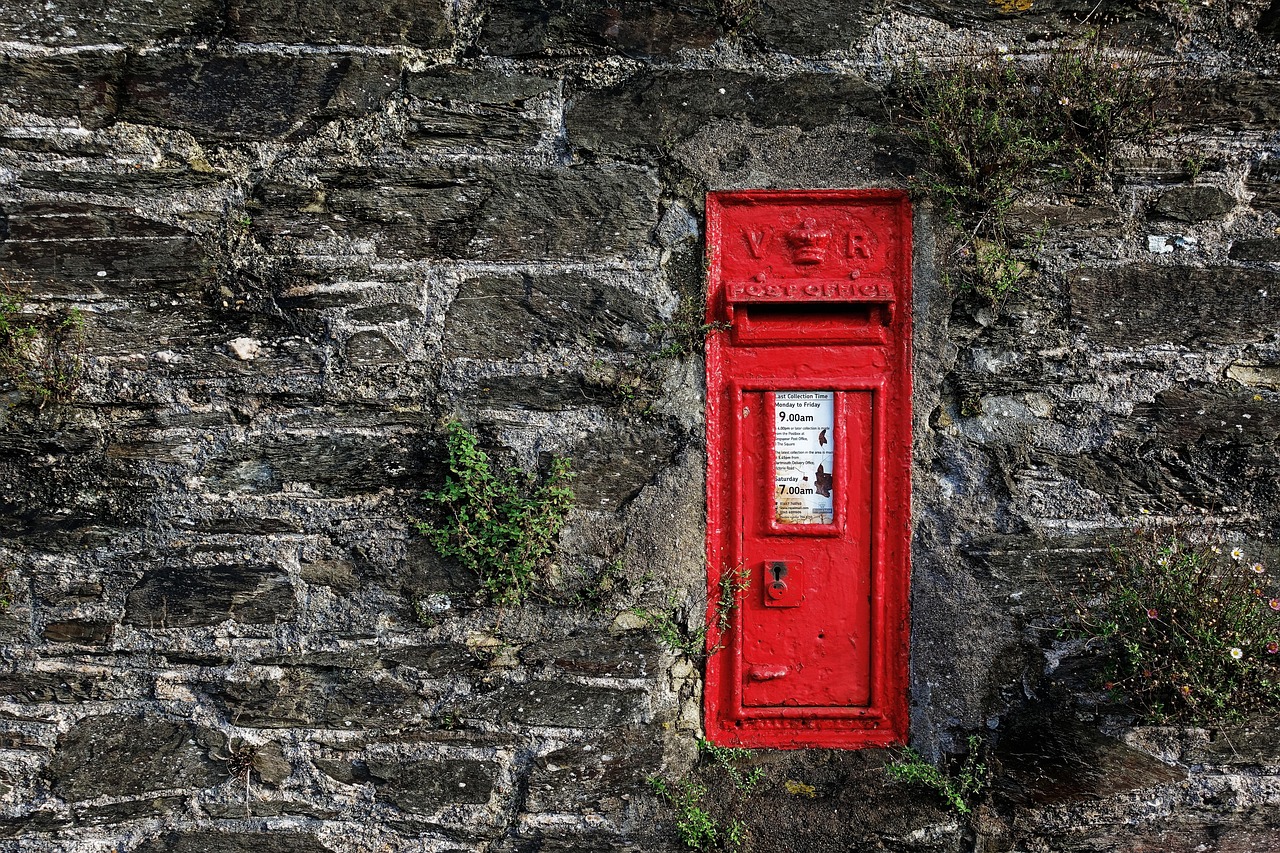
0,273,84,409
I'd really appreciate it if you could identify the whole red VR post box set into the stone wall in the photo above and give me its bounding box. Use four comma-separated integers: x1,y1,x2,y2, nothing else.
704,191,911,748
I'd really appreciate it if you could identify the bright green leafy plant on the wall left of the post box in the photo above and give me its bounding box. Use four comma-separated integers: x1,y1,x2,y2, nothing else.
415,421,573,605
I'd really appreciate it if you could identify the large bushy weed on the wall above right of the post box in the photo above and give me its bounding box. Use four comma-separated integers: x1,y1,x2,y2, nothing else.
892,40,1162,304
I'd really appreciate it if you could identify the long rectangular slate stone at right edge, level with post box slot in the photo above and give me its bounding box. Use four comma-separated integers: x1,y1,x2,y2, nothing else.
1068,265,1280,347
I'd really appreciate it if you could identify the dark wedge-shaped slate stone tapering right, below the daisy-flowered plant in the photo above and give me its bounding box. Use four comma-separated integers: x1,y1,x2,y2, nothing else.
995,711,1187,806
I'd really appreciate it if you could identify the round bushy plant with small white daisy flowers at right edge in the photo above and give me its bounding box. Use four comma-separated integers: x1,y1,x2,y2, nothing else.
1070,526,1280,724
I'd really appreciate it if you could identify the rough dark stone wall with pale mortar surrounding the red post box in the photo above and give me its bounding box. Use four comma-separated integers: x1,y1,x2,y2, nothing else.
0,0,1280,853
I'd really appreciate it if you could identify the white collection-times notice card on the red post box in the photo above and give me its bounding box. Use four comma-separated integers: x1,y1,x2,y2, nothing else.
773,391,836,524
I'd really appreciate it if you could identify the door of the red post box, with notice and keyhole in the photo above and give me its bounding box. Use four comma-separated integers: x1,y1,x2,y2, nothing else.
739,391,872,707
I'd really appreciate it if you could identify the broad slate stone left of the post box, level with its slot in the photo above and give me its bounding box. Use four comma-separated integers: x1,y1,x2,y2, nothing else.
444,273,659,359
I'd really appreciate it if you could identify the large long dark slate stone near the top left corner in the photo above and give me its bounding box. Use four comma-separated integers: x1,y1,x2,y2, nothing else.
120,53,399,142
